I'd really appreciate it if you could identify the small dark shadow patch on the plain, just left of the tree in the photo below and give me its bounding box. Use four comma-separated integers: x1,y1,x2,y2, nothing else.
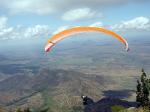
103,90,134,99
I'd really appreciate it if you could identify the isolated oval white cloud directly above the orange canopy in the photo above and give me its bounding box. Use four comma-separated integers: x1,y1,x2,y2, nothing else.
62,8,96,21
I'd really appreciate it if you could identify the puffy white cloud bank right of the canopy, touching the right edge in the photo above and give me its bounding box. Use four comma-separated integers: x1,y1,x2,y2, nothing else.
111,16,150,31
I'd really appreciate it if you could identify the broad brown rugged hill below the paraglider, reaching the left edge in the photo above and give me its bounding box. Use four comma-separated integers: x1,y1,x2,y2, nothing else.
0,69,115,109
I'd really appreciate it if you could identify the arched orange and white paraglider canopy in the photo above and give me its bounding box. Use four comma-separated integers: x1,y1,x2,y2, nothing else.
45,26,129,52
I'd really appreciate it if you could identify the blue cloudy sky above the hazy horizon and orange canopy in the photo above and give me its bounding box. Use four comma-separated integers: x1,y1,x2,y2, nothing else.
0,0,150,42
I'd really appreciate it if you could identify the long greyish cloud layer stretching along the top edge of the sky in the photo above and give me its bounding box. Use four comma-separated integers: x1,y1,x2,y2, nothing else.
0,0,149,15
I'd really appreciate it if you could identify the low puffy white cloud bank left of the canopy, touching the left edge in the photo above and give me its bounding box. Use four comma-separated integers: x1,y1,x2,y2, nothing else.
0,17,51,40
